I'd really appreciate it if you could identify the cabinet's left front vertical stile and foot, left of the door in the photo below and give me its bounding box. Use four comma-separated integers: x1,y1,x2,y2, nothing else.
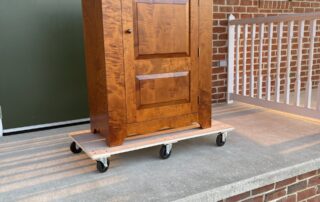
102,0,127,146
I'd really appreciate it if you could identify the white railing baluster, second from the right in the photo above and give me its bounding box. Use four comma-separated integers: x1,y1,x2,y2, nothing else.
295,20,305,106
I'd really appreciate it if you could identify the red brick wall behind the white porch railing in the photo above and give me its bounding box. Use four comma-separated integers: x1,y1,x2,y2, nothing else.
212,0,320,103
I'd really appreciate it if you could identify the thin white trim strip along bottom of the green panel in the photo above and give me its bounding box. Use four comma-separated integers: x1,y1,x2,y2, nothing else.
0,118,90,134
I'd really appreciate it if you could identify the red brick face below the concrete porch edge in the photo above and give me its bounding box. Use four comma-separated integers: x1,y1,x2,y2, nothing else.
221,169,320,202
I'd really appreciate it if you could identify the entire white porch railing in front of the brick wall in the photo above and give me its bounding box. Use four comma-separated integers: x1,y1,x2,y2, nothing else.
228,12,320,119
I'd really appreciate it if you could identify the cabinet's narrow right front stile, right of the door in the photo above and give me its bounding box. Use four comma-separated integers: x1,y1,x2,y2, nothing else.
199,0,212,128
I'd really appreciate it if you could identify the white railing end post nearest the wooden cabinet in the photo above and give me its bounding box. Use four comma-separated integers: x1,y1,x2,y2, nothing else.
227,15,235,103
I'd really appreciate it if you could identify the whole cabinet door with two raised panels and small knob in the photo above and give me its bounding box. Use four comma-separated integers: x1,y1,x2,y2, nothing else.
122,0,199,123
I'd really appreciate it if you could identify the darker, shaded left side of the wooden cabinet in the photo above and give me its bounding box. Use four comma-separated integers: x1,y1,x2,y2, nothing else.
82,0,108,137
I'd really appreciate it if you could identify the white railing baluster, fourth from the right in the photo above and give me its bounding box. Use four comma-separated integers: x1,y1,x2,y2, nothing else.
275,22,283,102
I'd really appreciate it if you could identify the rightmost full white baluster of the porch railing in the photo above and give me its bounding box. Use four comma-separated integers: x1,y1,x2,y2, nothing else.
305,19,317,108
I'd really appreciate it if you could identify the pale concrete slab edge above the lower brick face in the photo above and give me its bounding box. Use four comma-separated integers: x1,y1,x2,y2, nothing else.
176,158,320,202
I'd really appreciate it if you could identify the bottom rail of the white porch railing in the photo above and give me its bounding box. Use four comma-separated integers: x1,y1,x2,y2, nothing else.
231,94,320,119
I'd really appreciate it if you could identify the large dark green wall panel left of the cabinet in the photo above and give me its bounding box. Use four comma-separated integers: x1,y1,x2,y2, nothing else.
0,0,88,129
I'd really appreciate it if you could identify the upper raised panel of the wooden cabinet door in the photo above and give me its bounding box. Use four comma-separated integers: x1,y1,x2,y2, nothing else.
134,1,189,57
